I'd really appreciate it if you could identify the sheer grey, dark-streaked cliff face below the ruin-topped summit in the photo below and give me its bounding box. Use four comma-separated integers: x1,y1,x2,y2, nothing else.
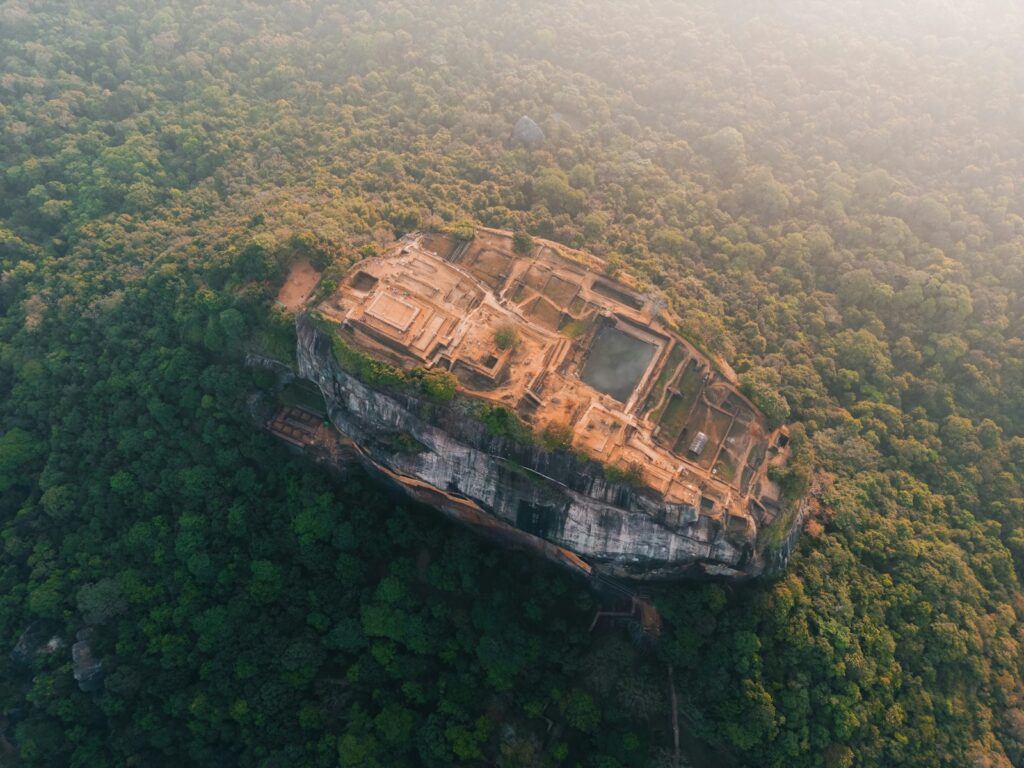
296,314,792,579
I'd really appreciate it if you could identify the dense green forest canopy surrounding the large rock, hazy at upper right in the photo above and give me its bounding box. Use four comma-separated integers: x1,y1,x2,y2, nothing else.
0,0,1024,768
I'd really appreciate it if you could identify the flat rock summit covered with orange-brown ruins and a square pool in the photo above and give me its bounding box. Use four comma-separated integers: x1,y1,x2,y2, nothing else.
318,227,775,526
